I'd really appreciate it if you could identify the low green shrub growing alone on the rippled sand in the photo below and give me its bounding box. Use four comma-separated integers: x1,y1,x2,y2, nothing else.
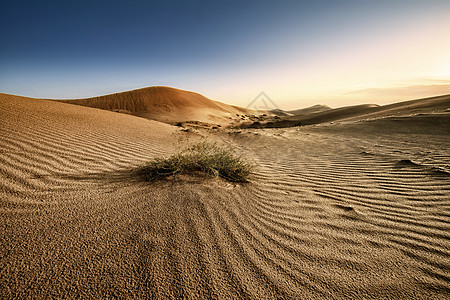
139,141,254,182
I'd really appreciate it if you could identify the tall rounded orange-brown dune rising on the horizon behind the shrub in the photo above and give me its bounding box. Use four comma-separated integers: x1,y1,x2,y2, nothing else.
55,87,246,123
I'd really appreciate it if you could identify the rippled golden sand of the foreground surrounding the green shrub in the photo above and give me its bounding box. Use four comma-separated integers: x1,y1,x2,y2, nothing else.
0,95,450,299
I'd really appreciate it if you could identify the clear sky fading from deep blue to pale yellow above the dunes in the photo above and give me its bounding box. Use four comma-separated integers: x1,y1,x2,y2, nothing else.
0,0,450,109
